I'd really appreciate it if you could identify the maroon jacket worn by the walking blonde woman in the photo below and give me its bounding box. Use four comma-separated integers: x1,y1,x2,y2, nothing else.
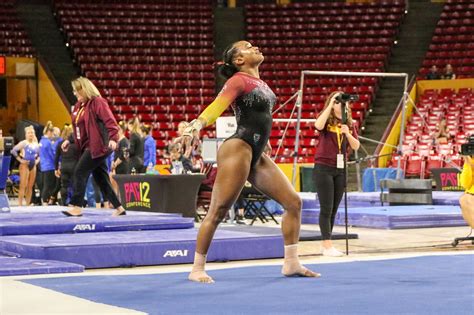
71,97,118,159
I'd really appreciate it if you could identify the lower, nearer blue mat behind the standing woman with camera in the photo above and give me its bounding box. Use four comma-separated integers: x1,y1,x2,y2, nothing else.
301,206,466,229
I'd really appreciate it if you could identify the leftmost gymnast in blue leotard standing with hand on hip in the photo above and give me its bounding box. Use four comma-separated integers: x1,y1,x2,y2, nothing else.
11,126,40,206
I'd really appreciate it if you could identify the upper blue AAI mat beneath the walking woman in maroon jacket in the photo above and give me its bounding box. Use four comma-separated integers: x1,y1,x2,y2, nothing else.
0,210,194,235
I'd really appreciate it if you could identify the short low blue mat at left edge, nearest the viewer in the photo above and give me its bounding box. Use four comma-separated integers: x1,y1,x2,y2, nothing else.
0,257,84,276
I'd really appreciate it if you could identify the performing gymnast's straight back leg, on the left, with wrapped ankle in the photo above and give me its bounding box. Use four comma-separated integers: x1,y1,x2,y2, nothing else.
188,139,252,283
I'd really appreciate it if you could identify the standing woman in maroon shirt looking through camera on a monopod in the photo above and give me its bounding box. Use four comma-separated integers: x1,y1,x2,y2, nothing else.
313,92,360,257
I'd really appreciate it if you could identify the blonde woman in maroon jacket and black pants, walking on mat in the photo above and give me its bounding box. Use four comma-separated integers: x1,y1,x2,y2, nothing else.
61,77,126,217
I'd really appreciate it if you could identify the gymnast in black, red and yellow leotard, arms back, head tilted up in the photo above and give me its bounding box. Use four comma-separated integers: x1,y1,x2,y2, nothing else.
183,41,320,283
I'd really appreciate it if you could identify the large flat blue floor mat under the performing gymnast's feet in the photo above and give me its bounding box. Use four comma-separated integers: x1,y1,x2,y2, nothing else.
24,255,474,315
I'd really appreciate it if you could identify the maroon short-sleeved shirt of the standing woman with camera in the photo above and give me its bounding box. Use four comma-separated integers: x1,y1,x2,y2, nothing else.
314,123,358,167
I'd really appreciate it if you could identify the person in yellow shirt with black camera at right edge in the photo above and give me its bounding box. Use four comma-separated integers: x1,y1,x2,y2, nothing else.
459,135,474,228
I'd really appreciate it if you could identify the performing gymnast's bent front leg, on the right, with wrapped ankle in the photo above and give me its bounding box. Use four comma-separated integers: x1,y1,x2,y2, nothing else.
249,154,321,277
